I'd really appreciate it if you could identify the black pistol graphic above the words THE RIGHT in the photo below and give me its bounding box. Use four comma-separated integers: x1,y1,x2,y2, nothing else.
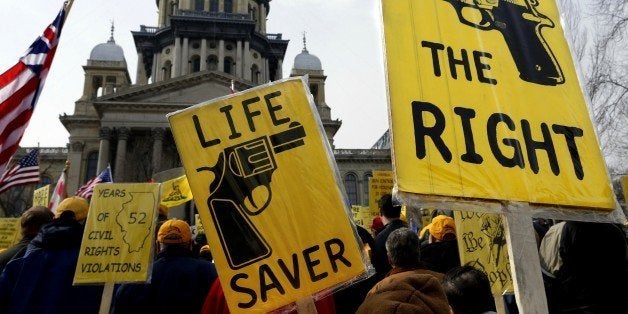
445,0,565,85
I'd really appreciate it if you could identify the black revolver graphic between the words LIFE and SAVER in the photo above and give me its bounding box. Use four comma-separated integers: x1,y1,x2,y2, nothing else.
196,122,305,269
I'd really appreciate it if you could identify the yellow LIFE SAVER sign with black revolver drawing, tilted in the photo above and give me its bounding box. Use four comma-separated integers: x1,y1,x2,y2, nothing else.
168,78,366,312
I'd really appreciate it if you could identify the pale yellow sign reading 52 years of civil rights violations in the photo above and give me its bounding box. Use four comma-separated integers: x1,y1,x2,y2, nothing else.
74,183,159,284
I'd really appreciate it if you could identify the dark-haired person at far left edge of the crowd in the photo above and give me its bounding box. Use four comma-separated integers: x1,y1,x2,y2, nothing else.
0,206,54,272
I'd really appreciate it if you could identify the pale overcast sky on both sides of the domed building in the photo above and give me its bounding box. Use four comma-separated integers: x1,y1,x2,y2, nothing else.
0,0,388,148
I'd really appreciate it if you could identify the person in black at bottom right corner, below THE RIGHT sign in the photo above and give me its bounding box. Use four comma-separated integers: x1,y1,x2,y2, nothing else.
539,221,628,313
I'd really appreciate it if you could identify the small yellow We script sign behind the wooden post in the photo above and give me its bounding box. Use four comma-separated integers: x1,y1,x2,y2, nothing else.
454,211,513,295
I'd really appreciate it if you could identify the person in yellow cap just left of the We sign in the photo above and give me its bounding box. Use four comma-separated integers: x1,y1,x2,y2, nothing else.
420,215,460,273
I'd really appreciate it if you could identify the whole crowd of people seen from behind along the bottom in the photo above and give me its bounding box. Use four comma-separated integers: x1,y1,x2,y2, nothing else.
0,194,628,314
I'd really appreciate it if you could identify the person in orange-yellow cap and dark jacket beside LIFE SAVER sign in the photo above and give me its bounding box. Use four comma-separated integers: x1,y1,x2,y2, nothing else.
112,219,217,314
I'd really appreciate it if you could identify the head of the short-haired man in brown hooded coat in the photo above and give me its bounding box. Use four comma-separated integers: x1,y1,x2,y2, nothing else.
386,227,421,268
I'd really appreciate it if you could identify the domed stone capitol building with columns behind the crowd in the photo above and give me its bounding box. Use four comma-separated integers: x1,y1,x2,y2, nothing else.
7,0,391,216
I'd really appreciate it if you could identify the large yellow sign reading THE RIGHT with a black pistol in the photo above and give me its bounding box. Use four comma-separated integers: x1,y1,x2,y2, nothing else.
382,0,615,211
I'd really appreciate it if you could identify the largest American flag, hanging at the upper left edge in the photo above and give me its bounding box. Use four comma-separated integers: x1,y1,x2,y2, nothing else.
0,6,66,176
